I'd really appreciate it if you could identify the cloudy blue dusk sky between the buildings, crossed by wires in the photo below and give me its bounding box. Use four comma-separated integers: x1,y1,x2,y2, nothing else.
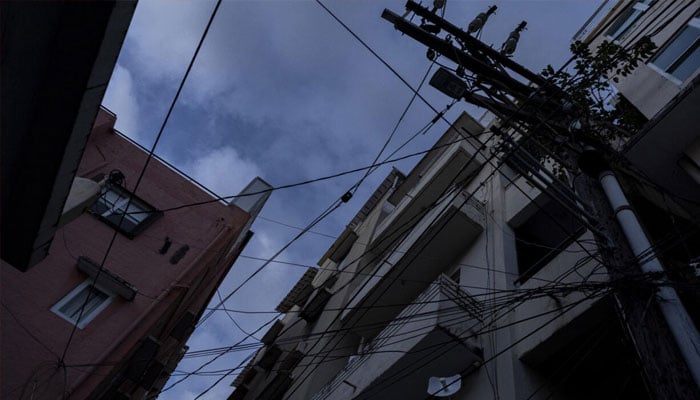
103,0,601,400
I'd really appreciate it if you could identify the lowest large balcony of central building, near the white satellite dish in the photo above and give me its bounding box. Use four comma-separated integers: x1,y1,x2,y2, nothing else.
313,275,483,400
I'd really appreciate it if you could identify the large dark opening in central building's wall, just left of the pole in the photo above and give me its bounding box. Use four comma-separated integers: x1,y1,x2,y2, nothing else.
513,200,585,283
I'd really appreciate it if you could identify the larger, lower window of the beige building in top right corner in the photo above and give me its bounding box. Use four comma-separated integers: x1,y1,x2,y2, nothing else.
651,13,700,83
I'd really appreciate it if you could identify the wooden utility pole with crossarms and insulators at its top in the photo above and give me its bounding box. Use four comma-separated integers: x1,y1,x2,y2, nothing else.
382,0,700,400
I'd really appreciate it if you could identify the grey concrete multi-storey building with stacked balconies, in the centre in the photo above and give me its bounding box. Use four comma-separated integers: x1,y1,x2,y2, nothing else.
229,110,646,399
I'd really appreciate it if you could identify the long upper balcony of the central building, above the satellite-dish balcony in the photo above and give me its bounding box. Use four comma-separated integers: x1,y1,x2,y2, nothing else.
341,195,485,337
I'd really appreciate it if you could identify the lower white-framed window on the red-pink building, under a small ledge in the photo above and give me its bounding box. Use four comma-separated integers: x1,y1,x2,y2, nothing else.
51,281,112,329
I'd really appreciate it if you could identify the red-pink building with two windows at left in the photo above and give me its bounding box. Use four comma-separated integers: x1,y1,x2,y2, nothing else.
0,109,269,399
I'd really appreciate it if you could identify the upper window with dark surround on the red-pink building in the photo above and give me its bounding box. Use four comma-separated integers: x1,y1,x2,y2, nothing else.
90,185,162,238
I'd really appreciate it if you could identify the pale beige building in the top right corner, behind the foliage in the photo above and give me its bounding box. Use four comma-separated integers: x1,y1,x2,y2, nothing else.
574,0,700,200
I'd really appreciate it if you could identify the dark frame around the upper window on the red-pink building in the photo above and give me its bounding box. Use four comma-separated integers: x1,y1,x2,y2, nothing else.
90,184,163,239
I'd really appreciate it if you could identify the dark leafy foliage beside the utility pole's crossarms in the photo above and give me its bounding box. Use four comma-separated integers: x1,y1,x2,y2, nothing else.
520,37,656,181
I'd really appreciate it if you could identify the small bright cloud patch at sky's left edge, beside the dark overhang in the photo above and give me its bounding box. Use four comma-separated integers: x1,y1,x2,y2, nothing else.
103,64,140,140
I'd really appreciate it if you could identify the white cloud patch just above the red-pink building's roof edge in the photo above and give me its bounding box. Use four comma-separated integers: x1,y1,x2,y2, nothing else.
184,146,262,196
